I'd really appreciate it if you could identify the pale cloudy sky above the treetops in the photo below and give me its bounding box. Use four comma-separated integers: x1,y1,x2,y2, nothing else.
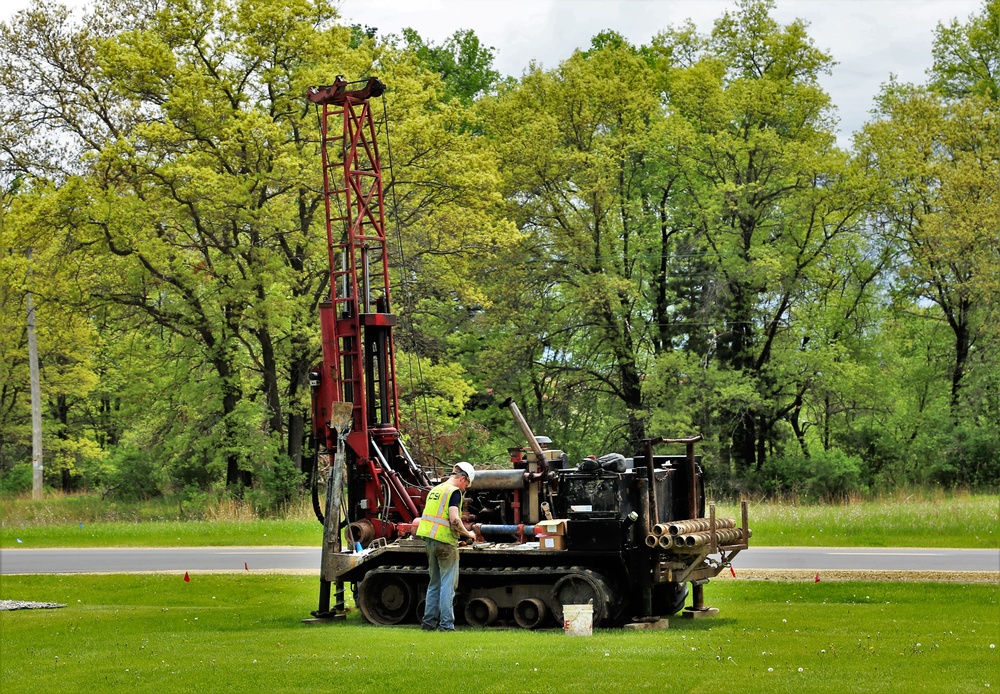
0,0,983,147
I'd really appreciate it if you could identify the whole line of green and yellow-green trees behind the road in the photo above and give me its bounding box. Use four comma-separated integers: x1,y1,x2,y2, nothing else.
0,0,1000,505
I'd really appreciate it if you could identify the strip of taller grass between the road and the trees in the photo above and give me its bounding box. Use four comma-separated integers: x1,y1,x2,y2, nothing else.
0,494,1000,548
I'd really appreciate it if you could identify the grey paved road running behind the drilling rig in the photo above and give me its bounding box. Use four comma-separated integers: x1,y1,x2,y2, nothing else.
0,547,1000,575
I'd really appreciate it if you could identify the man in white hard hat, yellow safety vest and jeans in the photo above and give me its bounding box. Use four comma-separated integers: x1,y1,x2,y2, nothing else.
417,462,476,631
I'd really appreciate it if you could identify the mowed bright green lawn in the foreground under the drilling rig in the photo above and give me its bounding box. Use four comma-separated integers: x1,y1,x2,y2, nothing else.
0,574,1000,694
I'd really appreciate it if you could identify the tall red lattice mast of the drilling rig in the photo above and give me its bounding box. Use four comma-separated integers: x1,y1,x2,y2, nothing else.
308,77,427,538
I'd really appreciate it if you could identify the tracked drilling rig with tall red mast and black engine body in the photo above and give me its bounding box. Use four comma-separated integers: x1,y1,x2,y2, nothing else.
308,77,751,629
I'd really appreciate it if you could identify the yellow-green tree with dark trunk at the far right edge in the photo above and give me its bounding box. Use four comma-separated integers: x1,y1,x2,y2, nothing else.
859,35,1000,419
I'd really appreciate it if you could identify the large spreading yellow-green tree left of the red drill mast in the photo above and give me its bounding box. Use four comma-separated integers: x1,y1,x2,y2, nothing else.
4,1,360,485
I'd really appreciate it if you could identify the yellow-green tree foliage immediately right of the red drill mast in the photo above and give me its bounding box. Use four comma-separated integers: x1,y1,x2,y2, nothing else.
379,32,519,466
